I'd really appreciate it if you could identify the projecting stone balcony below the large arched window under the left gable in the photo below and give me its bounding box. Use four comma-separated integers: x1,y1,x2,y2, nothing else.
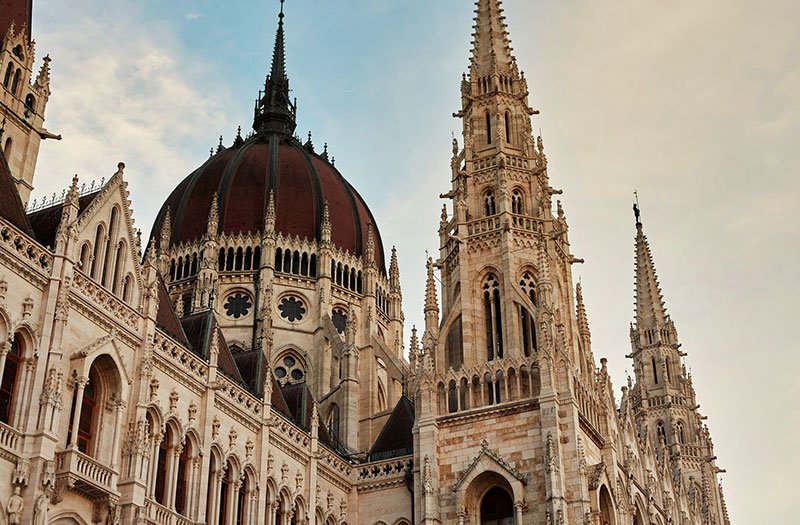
56,448,118,500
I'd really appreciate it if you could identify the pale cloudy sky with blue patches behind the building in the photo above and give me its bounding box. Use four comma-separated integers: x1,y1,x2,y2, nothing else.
28,0,800,524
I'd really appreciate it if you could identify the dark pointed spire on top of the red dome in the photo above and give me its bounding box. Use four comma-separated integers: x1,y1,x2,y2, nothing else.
253,0,297,137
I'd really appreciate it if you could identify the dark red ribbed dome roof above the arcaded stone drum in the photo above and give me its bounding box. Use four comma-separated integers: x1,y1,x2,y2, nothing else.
151,134,386,274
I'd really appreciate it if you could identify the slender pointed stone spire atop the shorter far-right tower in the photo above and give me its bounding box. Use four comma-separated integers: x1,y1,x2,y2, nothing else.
633,203,669,330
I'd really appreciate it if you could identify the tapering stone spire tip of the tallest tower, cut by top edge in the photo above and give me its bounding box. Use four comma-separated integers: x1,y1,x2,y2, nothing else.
470,0,517,80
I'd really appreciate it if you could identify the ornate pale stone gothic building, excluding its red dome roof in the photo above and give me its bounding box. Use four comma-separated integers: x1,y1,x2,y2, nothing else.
0,0,729,525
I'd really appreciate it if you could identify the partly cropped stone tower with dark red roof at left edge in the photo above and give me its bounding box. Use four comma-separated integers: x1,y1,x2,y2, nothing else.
0,0,56,202
